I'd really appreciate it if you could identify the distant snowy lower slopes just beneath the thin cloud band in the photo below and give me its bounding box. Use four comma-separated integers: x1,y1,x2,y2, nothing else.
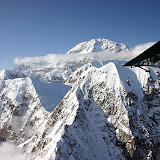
15,58,91,83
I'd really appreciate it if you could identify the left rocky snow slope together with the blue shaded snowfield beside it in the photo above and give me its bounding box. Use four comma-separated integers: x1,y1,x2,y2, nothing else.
0,76,70,148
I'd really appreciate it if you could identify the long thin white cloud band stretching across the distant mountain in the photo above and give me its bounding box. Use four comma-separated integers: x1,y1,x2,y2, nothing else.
14,42,155,66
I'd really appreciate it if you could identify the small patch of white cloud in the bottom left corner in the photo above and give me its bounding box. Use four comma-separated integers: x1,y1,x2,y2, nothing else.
0,142,26,160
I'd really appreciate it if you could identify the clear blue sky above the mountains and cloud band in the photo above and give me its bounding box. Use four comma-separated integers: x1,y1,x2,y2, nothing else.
0,0,160,69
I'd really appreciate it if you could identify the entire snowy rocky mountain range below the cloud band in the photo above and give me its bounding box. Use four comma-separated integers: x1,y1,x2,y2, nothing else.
0,39,160,160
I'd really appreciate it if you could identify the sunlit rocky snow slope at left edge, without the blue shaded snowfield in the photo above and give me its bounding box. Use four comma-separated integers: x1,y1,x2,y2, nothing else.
0,78,48,144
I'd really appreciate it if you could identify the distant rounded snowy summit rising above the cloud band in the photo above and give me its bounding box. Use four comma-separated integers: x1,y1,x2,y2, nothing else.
67,38,128,54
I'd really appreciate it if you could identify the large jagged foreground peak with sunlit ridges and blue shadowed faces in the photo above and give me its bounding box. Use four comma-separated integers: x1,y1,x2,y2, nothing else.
17,62,160,160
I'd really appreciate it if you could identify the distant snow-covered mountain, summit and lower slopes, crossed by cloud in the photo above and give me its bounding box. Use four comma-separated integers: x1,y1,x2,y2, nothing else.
15,38,129,82
